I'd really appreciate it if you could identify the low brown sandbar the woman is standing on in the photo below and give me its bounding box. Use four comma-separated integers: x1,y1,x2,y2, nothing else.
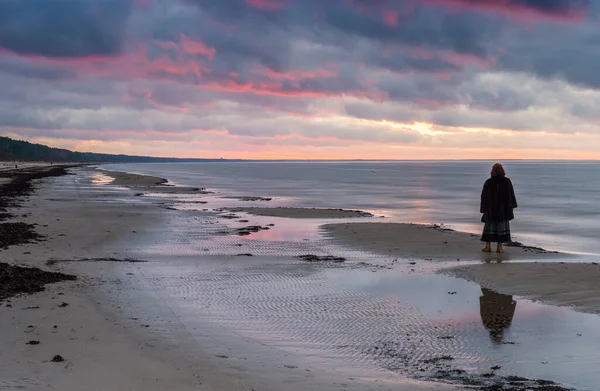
322,222,564,261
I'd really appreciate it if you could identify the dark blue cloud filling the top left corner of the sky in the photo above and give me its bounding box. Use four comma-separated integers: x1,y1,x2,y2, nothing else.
0,0,132,57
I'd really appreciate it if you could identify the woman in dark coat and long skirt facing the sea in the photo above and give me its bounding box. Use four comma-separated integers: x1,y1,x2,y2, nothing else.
479,163,517,253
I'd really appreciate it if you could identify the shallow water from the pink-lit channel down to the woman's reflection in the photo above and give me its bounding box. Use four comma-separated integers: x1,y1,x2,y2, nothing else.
89,164,600,391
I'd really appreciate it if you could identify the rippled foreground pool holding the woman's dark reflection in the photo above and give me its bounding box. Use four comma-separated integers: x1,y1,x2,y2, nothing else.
141,257,600,391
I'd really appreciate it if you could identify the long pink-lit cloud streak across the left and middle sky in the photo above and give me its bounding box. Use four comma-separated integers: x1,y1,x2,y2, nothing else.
5,44,387,103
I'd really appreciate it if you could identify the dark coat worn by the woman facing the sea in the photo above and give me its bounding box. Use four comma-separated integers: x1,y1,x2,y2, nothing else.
479,177,517,222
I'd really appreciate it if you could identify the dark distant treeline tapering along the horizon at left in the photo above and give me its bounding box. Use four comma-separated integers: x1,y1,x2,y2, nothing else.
0,137,225,163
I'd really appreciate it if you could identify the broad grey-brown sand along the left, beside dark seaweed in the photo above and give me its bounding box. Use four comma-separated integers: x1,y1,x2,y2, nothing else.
0,168,460,391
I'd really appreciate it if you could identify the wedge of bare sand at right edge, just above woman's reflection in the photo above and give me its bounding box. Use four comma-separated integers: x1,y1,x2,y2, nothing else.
444,263,600,314
